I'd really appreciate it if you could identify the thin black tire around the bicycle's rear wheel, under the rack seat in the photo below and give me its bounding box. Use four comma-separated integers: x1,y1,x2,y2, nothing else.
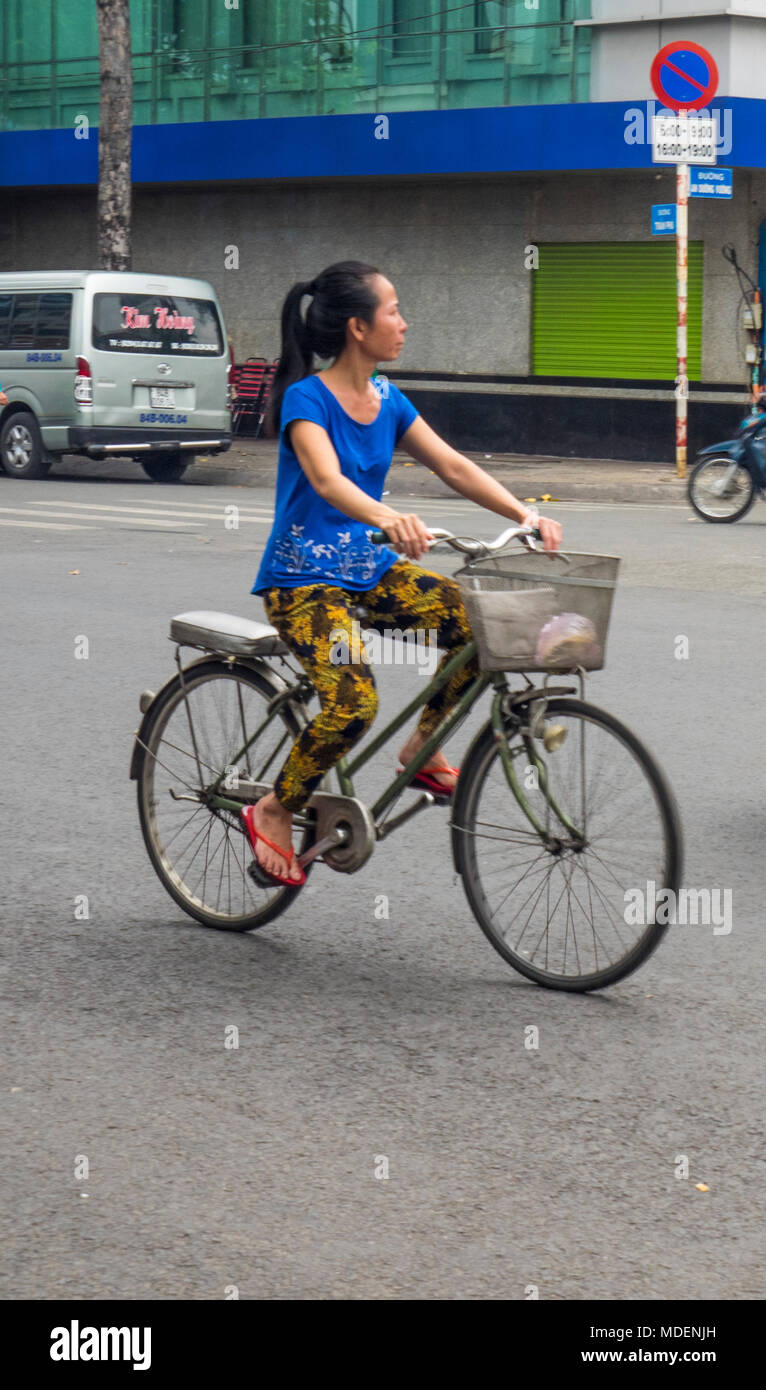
136,659,316,931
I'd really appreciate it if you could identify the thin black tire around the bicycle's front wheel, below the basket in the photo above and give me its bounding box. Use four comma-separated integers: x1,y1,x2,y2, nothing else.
453,698,683,992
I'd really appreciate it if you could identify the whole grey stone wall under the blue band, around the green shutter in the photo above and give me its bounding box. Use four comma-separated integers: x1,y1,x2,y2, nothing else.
0,170,766,382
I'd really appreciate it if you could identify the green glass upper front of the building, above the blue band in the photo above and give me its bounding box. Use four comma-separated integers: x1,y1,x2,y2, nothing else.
0,0,589,131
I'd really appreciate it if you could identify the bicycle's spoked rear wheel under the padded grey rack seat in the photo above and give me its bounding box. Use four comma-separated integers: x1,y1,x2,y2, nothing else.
138,660,314,931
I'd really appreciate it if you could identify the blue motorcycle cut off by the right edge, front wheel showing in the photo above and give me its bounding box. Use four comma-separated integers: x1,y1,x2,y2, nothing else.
688,393,766,521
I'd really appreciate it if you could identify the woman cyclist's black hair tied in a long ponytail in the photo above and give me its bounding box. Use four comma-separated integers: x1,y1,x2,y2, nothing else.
266,261,380,438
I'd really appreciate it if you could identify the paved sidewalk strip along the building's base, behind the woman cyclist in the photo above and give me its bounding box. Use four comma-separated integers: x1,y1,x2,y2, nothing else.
192,438,690,505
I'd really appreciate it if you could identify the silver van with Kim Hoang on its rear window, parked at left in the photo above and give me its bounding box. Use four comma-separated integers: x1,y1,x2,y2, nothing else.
0,270,234,482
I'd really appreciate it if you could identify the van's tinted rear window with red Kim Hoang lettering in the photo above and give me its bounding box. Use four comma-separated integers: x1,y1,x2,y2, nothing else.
93,292,224,357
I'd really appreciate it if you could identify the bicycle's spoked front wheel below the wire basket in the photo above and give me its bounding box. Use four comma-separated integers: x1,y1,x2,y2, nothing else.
453,699,681,991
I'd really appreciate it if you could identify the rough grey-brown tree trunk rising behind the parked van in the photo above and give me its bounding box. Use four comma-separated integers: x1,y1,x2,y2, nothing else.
96,0,133,270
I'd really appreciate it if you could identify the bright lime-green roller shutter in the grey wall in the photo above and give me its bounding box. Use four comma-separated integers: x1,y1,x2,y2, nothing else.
532,242,702,381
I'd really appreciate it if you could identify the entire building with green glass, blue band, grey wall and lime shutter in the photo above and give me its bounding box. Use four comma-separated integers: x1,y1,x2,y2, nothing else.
0,0,766,457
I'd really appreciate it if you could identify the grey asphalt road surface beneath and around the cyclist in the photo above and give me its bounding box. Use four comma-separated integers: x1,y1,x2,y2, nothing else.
0,478,766,1300
